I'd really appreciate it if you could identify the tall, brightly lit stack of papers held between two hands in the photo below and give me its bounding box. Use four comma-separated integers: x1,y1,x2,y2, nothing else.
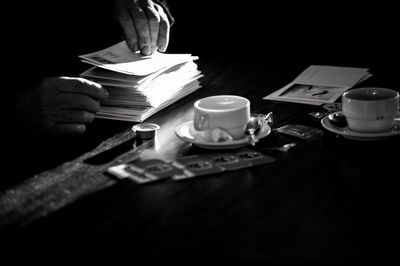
79,41,203,122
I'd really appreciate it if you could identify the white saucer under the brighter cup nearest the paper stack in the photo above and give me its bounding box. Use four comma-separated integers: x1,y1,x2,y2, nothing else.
175,120,271,149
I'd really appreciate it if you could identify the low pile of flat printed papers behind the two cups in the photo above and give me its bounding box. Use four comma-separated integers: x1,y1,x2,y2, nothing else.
263,65,372,105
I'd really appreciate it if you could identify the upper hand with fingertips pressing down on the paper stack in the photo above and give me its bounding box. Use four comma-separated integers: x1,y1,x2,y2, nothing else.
114,0,170,55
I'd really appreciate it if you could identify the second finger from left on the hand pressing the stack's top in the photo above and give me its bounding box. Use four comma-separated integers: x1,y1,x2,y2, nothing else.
129,2,151,55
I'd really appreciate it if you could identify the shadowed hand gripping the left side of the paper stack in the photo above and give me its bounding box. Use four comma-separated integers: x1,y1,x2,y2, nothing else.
17,77,108,135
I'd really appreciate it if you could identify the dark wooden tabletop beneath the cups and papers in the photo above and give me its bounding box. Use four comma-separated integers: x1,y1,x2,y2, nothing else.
0,59,400,264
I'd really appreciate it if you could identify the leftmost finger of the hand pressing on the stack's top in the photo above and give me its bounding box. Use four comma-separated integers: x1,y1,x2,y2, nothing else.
114,1,139,52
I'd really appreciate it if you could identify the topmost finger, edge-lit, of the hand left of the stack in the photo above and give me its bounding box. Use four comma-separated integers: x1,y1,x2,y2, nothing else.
57,77,108,100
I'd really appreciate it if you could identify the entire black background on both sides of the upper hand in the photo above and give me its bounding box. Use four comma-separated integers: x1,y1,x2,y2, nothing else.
2,0,400,83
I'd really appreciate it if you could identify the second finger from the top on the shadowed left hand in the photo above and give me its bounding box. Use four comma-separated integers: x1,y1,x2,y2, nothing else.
59,93,100,113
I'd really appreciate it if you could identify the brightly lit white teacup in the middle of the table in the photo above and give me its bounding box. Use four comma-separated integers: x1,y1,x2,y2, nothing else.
193,95,250,139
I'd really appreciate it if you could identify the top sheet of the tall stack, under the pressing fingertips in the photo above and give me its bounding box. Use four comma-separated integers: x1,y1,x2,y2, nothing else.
79,41,198,76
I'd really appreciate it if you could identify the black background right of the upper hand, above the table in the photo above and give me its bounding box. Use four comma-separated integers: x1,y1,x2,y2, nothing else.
169,0,399,65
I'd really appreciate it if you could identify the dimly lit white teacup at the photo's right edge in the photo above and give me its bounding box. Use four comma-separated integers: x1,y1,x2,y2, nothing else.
342,87,399,132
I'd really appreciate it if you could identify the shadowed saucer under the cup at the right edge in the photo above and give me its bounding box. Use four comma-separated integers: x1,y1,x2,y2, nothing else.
321,111,400,140
